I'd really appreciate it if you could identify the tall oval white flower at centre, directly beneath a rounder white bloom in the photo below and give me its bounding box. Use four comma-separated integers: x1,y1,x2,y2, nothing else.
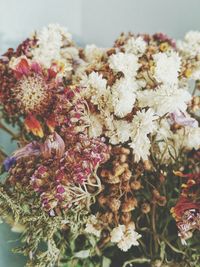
111,78,137,118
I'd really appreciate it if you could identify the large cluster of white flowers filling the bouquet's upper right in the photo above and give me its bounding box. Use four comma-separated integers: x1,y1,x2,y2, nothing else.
77,33,200,162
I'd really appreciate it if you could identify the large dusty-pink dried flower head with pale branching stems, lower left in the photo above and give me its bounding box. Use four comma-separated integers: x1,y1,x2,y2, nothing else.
13,132,109,215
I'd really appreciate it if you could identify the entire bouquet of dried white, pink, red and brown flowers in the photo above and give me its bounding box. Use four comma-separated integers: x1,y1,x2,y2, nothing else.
0,25,200,267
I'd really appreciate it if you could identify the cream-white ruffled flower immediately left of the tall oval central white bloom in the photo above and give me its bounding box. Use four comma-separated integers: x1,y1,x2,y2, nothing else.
81,71,108,109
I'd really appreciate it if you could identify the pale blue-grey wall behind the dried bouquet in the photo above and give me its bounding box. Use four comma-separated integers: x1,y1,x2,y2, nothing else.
0,0,200,267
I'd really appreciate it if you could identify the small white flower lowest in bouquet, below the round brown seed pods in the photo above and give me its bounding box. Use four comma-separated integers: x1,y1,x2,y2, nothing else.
111,223,141,251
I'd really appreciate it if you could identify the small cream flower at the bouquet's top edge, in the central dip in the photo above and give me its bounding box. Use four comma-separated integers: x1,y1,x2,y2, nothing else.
84,44,105,62
